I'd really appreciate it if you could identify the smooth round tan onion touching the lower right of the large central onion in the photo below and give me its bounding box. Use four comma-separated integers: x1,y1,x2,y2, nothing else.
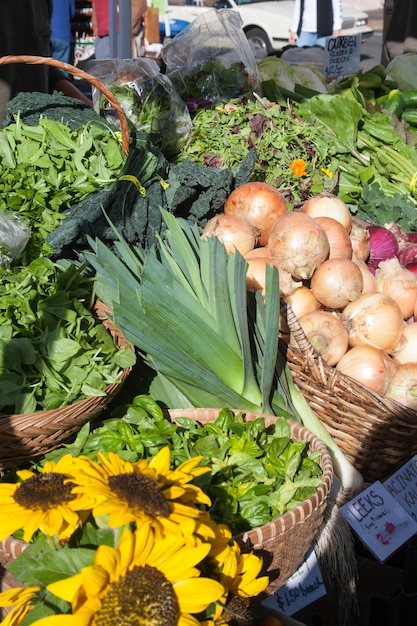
310,259,363,309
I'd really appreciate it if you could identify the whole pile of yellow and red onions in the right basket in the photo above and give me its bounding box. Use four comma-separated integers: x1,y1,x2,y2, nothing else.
207,182,417,408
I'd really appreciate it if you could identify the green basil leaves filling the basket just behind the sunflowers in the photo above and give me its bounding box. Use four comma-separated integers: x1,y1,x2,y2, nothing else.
40,395,322,534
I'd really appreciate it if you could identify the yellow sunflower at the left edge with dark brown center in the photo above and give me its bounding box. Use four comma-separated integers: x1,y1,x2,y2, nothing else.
0,454,93,542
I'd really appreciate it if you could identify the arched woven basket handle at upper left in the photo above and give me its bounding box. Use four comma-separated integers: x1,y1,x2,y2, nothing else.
0,54,129,154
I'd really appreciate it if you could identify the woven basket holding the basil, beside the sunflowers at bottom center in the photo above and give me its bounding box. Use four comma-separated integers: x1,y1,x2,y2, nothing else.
168,409,333,594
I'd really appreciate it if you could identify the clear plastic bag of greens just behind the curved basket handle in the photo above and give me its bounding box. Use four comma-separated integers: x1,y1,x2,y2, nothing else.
87,58,192,160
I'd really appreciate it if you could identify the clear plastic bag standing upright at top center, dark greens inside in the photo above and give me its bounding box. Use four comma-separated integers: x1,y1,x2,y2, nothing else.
162,9,260,103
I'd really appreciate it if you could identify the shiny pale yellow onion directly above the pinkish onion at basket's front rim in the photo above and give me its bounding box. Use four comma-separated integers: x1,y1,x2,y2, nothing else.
341,291,405,353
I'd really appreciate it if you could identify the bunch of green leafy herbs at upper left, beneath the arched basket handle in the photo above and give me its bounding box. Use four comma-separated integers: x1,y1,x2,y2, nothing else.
0,116,126,262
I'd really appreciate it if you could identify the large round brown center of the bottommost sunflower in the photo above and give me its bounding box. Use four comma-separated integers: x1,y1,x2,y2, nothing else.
94,565,180,626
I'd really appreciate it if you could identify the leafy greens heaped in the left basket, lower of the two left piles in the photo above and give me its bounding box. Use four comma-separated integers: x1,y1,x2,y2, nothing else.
0,257,135,414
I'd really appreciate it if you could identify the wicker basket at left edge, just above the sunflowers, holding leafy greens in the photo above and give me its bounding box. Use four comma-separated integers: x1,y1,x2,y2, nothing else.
0,303,133,468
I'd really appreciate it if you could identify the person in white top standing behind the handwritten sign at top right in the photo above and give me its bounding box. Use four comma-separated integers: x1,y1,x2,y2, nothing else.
288,0,343,48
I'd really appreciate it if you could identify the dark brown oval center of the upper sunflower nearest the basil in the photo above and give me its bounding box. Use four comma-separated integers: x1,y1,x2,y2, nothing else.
108,472,171,517
